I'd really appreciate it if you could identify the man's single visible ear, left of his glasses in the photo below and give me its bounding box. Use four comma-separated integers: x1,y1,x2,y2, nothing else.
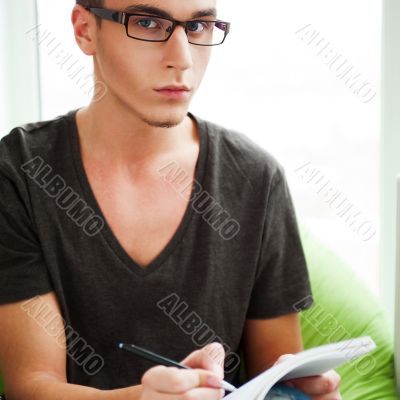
71,4,97,56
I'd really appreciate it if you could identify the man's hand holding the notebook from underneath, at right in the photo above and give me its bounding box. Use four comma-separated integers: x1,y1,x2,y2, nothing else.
276,354,342,400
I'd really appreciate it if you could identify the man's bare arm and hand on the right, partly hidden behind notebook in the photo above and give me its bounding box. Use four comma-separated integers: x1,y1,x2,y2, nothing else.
243,314,341,400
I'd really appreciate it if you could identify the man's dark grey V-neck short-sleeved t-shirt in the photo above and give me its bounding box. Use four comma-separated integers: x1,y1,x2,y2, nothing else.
0,110,311,389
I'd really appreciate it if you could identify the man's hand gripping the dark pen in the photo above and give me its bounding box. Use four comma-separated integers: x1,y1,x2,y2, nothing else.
140,342,225,400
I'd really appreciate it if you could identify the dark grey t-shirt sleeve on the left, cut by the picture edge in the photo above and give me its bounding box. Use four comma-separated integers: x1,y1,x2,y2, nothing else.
0,171,53,304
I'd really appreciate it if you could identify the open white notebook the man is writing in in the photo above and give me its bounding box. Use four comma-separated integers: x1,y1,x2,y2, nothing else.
224,336,376,400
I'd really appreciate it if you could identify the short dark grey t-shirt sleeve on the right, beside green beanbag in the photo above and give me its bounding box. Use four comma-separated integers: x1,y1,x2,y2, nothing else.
247,167,313,319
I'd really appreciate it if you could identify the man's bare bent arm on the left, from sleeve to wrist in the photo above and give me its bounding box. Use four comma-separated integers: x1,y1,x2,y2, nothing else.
0,292,142,400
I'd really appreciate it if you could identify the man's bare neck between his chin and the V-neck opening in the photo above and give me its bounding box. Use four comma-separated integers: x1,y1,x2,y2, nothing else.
76,101,198,167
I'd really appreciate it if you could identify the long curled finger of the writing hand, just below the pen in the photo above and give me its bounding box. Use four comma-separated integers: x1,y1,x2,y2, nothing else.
141,365,221,393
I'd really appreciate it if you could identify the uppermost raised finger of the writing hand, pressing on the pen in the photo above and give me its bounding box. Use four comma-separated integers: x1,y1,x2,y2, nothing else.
182,342,225,379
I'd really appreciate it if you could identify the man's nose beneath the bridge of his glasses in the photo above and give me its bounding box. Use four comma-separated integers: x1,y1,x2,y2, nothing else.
164,25,193,70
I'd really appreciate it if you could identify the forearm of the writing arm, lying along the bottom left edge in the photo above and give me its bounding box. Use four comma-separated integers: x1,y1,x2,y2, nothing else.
6,376,142,400
